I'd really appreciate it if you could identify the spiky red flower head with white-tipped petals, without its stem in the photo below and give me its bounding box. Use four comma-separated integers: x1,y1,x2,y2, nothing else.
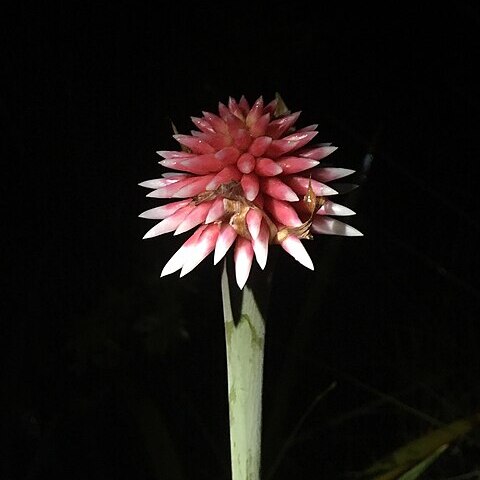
140,95,362,288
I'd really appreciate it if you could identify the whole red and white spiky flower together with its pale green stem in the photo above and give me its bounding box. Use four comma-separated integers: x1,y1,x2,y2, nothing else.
140,95,362,480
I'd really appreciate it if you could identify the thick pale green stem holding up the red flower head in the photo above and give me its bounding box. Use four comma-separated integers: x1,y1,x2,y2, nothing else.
222,262,265,480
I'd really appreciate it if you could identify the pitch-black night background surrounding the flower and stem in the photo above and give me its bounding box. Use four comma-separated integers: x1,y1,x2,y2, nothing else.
0,1,480,480
